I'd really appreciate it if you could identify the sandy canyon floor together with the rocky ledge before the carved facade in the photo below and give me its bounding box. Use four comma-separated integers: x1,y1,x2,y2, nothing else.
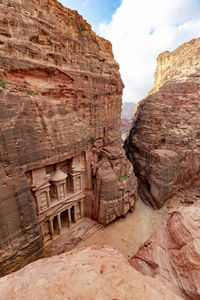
44,198,168,258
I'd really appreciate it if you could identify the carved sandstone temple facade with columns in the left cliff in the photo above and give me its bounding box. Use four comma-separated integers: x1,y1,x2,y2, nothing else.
26,155,85,244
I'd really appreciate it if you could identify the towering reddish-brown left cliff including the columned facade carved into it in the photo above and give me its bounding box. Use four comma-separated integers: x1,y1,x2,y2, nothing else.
0,0,137,275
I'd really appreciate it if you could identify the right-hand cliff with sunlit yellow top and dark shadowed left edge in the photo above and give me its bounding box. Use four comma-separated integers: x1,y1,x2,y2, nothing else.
125,39,200,208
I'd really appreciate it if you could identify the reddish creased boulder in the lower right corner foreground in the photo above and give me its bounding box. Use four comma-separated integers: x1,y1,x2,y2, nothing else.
130,201,200,300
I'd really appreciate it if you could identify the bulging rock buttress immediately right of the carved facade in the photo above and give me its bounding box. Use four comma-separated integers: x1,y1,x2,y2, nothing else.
92,146,138,224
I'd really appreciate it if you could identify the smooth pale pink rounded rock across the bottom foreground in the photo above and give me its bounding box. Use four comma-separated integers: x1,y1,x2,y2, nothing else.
0,247,184,300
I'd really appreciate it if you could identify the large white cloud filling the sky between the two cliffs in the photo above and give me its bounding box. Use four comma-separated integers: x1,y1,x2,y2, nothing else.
99,0,200,102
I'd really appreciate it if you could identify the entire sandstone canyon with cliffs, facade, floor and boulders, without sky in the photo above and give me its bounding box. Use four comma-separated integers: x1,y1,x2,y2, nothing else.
0,0,200,300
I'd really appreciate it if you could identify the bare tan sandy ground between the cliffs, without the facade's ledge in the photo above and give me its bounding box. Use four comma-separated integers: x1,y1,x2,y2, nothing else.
76,199,167,258
